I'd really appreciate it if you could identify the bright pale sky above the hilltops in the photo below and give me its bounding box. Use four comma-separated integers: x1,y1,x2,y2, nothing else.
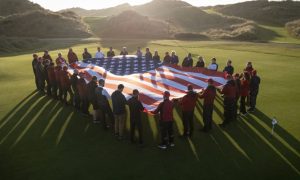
30,0,288,11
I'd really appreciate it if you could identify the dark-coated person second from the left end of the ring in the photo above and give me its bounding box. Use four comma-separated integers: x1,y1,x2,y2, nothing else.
34,57,46,93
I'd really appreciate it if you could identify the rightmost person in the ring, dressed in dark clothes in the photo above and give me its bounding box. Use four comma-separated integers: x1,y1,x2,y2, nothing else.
248,70,260,112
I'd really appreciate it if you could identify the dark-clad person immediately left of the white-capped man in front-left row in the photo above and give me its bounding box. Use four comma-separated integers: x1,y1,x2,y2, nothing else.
87,76,100,123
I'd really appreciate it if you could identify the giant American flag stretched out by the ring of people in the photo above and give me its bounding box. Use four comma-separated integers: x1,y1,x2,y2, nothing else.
70,55,226,111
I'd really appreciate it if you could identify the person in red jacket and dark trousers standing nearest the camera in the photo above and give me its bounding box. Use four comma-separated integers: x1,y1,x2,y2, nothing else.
151,91,175,149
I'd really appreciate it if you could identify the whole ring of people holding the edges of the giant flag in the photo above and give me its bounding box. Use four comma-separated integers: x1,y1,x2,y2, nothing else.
32,47,260,149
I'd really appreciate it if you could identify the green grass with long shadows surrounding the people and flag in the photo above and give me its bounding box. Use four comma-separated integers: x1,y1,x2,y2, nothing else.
0,40,300,180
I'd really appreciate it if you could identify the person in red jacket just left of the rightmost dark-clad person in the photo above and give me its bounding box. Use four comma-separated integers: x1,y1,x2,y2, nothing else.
240,71,250,115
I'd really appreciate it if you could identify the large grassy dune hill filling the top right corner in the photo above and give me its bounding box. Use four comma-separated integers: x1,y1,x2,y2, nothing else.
214,1,300,26
